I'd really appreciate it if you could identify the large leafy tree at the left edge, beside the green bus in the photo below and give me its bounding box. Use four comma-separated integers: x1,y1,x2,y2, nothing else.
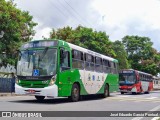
0,0,37,65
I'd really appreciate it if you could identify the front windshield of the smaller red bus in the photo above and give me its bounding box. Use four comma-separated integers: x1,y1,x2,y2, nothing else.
119,73,136,84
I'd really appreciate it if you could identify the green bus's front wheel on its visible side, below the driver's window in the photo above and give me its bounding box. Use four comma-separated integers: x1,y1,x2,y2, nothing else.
69,84,80,102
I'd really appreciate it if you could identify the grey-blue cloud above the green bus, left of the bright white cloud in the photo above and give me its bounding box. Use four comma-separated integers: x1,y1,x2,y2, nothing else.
14,0,99,39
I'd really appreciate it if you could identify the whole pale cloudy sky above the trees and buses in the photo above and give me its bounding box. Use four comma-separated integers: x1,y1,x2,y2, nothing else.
14,0,160,51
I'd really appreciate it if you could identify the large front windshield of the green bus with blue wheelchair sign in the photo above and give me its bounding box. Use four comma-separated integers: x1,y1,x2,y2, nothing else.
17,47,57,76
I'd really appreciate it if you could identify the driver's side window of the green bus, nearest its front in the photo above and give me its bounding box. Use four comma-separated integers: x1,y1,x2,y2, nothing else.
60,49,70,71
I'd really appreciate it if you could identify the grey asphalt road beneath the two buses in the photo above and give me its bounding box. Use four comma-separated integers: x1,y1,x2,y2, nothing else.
0,91,160,120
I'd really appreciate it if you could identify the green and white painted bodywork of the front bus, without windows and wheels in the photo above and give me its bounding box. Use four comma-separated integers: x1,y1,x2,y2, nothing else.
15,40,119,97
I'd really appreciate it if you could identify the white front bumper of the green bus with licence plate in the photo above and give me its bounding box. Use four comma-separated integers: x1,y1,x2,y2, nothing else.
15,84,58,97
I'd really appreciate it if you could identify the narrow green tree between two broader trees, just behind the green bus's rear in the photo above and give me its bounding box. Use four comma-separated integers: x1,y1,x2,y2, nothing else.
113,40,130,69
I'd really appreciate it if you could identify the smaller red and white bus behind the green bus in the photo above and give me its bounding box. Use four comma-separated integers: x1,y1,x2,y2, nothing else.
119,69,153,94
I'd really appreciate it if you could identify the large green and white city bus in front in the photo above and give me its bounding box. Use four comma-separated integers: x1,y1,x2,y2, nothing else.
15,40,119,101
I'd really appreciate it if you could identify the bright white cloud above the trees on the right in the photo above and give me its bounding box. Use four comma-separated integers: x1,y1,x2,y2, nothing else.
93,0,160,50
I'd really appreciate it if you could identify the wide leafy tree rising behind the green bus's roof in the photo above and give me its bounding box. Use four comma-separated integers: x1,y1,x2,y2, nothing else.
50,26,115,57
